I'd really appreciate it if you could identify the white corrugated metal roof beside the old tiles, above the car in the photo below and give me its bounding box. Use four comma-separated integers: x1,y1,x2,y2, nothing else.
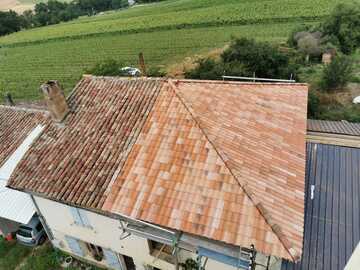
0,125,44,224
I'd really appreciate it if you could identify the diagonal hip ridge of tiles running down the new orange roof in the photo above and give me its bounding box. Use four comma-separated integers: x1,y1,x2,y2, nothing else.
168,79,300,261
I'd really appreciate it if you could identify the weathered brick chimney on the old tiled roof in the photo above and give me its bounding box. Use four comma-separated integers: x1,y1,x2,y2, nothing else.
40,81,69,122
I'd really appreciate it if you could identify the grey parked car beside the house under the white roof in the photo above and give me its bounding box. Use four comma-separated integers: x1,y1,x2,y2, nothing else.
16,215,46,246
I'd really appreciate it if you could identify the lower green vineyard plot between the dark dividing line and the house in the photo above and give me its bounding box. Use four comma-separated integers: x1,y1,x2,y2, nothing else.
0,24,298,100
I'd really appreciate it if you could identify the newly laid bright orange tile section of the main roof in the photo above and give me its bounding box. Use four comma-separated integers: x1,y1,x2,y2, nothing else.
103,81,307,259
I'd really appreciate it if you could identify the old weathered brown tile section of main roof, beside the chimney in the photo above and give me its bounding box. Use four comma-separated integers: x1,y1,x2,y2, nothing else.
9,78,162,208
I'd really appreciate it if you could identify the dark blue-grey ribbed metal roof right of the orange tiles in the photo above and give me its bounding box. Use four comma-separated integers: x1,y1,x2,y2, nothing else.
281,143,360,270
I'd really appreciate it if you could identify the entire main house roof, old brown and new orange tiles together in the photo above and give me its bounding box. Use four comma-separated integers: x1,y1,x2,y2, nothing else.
10,77,307,260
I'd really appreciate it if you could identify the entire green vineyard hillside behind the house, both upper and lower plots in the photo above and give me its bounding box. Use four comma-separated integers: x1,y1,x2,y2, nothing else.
0,0,351,99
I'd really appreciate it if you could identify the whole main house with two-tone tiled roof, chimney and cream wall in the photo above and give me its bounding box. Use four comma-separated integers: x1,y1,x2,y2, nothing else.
8,76,307,270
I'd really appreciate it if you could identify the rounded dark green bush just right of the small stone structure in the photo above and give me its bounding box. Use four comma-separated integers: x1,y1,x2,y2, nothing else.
320,55,353,91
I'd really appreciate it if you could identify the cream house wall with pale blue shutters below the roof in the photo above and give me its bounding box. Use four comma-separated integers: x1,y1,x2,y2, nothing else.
35,197,240,270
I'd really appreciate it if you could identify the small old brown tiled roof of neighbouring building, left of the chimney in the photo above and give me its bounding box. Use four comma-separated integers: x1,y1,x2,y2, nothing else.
0,105,46,167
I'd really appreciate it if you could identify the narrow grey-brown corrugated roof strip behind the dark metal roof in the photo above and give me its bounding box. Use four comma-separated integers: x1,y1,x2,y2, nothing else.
307,119,360,136
